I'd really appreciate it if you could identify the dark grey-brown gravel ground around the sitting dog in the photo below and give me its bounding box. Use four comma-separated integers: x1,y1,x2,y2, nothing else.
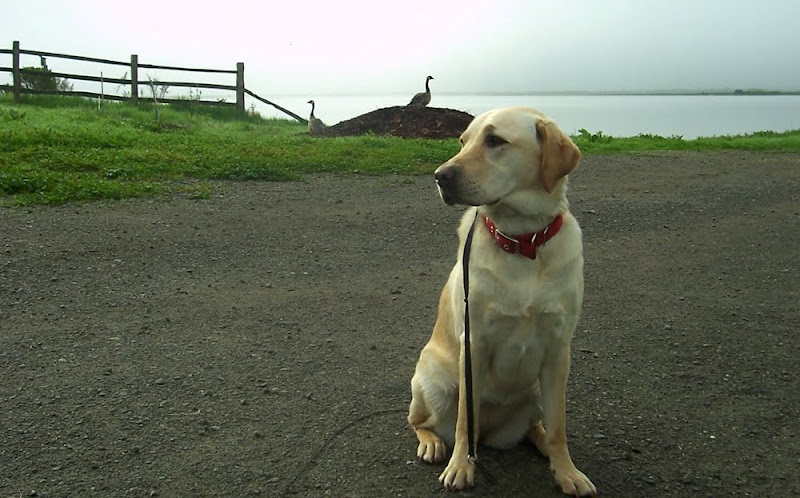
0,153,800,498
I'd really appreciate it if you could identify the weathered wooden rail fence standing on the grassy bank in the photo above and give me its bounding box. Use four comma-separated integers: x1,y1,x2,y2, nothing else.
0,41,307,123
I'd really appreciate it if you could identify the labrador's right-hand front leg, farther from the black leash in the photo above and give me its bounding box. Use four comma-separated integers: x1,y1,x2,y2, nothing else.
534,344,597,496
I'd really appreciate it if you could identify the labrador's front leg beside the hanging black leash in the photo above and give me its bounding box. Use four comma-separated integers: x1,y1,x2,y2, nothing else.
439,334,485,491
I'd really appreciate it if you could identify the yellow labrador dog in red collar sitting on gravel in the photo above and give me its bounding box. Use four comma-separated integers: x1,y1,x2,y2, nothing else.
408,107,596,496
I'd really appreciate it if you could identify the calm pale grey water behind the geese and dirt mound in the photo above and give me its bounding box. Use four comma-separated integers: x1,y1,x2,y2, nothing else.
257,94,800,139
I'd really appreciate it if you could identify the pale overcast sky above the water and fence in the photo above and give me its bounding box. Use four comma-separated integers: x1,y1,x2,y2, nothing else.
0,0,800,96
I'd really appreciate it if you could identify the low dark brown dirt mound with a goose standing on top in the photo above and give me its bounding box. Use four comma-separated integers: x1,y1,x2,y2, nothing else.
324,106,473,138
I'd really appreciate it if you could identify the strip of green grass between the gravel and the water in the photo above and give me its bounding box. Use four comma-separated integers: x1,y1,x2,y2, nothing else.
0,95,800,205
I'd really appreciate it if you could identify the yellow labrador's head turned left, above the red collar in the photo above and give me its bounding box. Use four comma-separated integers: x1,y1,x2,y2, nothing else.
434,107,581,206
